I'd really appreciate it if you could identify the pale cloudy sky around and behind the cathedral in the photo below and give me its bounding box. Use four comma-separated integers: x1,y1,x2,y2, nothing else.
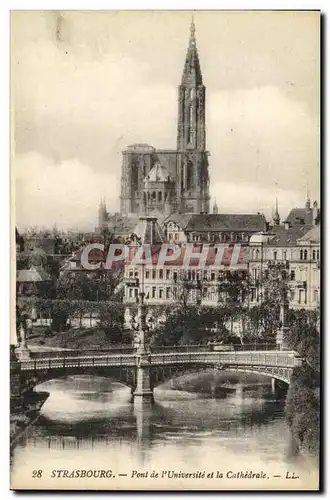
11,11,320,229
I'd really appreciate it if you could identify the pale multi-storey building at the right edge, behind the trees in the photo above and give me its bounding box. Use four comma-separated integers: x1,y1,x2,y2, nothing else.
249,221,320,309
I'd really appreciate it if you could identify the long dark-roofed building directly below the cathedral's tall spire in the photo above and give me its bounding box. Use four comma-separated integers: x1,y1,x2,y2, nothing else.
162,213,268,243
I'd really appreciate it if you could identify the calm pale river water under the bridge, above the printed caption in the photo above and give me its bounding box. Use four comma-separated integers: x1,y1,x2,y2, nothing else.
13,376,314,480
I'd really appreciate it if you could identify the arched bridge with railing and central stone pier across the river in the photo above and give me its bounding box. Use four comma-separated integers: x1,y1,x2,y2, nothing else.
11,346,302,408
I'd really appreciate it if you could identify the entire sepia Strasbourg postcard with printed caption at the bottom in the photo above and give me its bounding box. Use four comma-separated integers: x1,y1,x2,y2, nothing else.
10,10,321,491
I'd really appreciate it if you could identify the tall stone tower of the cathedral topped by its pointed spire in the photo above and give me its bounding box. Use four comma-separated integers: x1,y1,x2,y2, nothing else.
177,20,210,212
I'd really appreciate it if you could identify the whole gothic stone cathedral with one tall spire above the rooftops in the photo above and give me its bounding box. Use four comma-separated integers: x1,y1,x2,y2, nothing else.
120,22,210,217
